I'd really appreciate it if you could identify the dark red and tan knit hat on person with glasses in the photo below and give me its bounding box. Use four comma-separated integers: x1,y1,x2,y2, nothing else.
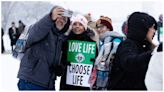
96,16,113,31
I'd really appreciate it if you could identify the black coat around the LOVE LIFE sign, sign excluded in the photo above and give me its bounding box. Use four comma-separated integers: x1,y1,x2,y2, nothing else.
60,31,98,90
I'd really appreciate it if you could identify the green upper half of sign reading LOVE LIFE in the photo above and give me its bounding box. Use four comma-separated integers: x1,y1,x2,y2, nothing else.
67,40,96,64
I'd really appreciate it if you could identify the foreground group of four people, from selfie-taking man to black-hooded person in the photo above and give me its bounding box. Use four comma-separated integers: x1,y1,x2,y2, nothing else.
17,6,161,90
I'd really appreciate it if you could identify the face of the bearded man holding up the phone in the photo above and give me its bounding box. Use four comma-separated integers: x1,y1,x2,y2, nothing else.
55,16,68,30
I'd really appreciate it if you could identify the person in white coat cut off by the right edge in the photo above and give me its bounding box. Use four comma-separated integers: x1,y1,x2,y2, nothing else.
145,43,163,91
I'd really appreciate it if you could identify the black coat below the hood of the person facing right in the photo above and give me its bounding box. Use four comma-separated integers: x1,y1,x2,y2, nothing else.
110,39,152,90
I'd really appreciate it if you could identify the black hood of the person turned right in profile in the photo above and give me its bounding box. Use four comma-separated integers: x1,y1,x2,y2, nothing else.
127,12,157,42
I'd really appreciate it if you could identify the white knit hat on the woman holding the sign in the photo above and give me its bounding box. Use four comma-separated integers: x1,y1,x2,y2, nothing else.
71,14,88,30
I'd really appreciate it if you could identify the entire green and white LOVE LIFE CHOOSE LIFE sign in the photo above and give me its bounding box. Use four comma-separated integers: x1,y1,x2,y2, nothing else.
66,40,96,87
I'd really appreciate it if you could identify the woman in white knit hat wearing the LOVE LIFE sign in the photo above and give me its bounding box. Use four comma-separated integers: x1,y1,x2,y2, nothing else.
60,14,97,90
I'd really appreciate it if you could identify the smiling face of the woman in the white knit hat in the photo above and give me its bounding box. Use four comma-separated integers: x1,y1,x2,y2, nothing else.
72,22,85,34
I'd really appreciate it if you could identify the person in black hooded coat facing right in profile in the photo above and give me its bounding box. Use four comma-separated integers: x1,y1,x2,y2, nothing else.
108,12,157,90
